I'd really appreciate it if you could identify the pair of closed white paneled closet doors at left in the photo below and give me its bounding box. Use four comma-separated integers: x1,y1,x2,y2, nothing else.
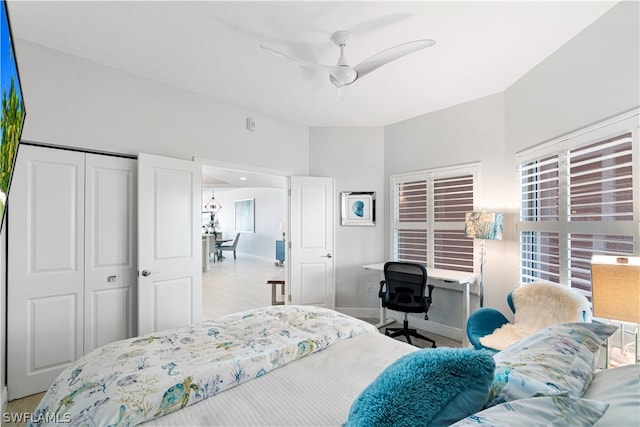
7,145,136,399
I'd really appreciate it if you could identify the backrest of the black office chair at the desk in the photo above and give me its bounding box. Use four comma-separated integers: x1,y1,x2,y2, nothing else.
381,261,433,313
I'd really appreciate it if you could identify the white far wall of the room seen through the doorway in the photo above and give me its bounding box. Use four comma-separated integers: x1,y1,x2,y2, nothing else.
203,186,286,262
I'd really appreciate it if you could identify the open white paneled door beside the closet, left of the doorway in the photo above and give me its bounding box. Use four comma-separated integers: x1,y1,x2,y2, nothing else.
138,153,202,335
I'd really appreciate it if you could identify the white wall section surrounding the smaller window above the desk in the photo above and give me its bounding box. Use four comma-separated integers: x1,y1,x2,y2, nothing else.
385,93,514,328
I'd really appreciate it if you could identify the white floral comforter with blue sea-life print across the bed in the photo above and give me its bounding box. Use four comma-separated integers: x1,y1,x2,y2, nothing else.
31,306,375,426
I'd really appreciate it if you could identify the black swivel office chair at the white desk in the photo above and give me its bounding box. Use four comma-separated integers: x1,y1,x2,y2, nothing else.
378,261,436,348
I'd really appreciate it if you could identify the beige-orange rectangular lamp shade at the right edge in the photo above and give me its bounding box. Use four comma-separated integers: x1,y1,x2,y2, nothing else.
591,255,640,323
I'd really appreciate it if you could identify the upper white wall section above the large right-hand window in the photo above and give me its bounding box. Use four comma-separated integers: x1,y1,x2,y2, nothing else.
505,1,640,152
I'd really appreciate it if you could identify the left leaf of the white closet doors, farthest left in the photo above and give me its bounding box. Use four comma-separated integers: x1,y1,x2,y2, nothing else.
7,145,84,400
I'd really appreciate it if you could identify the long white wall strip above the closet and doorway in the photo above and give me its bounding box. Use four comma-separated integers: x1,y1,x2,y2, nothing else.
16,39,309,174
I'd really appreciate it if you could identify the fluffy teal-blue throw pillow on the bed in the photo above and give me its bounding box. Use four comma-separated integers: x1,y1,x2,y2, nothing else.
345,347,495,427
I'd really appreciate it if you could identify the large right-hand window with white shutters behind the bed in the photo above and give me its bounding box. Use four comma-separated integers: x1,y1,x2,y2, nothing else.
518,113,640,296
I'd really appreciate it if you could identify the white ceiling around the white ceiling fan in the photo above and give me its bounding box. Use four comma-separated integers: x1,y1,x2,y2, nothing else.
9,1,615,126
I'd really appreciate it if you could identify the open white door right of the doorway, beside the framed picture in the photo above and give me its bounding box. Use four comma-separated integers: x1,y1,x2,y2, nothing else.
287,176,335,308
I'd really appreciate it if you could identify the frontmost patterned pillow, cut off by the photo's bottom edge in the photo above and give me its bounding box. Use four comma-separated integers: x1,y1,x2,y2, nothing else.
450,396,609,427
